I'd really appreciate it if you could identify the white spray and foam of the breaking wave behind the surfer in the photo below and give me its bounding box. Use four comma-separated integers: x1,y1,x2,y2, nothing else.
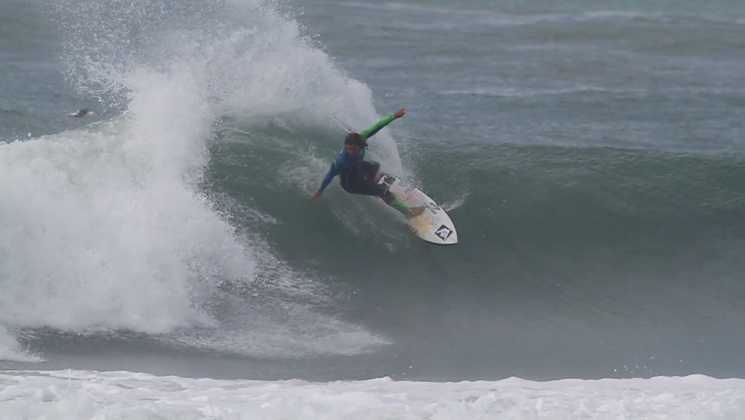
0,0,392,358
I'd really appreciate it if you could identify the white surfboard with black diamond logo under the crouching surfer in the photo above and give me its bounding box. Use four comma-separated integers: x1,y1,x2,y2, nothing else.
378,173,458,245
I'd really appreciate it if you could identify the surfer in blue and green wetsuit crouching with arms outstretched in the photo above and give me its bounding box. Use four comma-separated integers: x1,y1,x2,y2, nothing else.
311,108,425,218
